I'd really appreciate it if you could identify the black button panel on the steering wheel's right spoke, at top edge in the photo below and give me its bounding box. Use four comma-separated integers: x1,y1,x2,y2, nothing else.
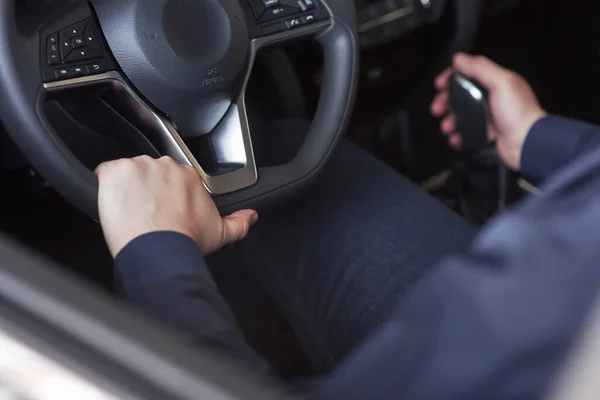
247,0,329,36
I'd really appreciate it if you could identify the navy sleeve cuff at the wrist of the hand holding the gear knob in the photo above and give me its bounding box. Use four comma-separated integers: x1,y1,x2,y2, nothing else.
521,116,600,185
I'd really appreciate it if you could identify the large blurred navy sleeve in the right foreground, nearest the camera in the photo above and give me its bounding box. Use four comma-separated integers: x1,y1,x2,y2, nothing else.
315,175,600,400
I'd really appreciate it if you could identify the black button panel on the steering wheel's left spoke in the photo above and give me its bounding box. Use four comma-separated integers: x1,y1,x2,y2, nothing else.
42,18,114,81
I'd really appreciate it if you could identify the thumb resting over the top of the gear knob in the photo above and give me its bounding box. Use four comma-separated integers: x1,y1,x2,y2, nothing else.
453,53,509,90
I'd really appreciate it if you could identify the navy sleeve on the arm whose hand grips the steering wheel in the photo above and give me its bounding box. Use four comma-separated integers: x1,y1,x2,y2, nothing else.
115,232,269,372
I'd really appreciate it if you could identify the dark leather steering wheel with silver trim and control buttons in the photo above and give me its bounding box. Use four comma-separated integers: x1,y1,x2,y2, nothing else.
0,0,359,218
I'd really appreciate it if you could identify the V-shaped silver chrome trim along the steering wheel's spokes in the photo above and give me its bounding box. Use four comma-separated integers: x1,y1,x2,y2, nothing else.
44,20,331,195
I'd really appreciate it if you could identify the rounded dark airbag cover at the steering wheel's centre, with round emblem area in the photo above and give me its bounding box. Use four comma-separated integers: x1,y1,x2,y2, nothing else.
92,0,250,137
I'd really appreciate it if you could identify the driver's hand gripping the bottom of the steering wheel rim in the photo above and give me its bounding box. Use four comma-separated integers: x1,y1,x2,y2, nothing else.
96,156,258,257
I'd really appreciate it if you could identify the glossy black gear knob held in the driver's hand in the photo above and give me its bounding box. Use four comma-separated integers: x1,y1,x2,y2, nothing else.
448,72,490,152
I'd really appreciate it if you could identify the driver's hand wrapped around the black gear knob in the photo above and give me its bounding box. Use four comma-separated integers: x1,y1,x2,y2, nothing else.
431,54,546,171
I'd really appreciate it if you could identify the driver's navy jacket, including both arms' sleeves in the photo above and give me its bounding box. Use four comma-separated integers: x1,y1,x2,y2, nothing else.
116,117,600,400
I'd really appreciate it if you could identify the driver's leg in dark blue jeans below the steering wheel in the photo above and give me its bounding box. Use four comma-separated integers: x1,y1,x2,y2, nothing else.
238,138,476,371
